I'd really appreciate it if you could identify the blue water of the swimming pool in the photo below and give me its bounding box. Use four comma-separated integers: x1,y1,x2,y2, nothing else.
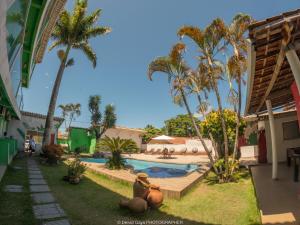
81,158,198,178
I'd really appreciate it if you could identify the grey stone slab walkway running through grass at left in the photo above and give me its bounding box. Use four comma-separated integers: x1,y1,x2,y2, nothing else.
28,158,70,225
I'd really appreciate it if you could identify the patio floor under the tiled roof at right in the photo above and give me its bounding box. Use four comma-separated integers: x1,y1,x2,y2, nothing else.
251,164,300,224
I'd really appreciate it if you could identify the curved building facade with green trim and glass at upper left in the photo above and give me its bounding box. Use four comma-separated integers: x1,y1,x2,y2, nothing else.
0,0,66,167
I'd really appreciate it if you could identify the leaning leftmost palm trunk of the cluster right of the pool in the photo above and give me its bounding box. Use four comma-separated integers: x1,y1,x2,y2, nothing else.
180,89,218,175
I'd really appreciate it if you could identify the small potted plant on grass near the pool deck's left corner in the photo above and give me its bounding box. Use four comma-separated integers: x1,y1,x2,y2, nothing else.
63,157,86,184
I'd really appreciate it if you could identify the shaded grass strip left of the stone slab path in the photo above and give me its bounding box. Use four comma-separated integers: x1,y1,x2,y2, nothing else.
0,159,40,225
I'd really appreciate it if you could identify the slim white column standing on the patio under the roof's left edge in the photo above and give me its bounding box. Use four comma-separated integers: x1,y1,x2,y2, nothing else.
266,100,278,180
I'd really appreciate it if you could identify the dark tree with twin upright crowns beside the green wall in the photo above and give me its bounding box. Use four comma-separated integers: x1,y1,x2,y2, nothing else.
88,95,117,140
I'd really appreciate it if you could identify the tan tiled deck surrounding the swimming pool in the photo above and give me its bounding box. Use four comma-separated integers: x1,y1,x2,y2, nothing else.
84,154,209,199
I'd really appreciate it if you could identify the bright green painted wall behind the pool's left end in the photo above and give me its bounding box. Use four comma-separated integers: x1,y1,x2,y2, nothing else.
69,127,96,153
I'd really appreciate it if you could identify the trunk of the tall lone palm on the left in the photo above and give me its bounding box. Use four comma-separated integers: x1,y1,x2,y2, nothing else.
43,46,71,146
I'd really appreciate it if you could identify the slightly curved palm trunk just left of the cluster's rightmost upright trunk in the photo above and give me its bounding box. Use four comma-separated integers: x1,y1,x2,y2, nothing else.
212,81,229,173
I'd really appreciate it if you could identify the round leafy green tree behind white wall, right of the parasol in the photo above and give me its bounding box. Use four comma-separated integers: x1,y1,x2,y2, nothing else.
165,114,200,137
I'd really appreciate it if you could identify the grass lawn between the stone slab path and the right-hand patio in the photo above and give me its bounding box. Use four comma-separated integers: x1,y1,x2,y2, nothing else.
41,160,260,225
